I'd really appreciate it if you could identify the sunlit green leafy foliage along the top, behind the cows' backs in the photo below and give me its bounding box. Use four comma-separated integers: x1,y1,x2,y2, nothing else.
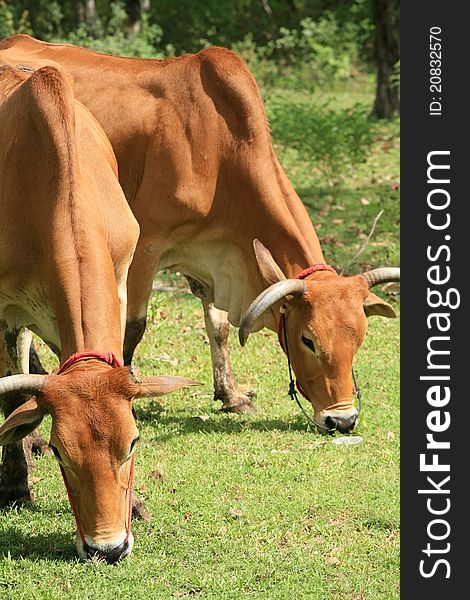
0,0,372,75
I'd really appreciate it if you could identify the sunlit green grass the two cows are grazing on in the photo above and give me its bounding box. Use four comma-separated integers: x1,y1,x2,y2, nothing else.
0,81,399,600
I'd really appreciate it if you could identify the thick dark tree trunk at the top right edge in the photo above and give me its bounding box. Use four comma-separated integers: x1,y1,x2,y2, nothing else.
372,0,400,119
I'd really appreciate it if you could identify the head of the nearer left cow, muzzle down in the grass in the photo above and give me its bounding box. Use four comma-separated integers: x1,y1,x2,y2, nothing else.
0,361,196,563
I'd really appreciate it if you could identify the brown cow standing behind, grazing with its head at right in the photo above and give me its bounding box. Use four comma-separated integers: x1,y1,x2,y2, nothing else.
0,35,399,432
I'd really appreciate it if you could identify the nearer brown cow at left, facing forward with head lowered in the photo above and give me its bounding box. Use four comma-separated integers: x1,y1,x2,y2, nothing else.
0,64,196,562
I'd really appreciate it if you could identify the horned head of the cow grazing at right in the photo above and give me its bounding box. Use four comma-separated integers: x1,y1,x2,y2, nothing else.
239,240,400,433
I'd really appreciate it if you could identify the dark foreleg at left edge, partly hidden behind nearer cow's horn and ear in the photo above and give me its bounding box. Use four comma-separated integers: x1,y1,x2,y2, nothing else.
0,329,33,507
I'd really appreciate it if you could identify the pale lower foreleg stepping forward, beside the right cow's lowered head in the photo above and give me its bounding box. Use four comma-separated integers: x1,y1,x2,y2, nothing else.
202,300,256,413
